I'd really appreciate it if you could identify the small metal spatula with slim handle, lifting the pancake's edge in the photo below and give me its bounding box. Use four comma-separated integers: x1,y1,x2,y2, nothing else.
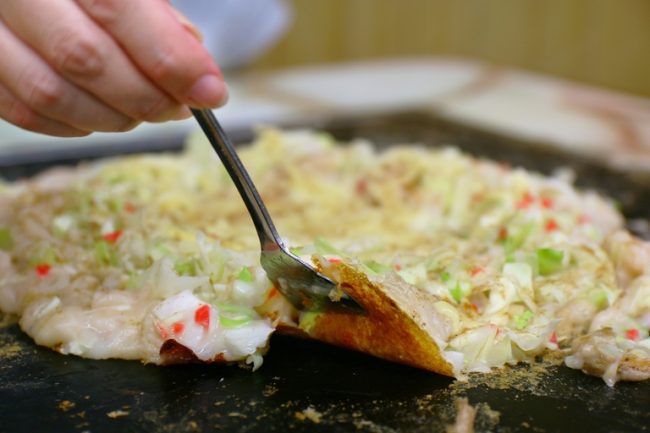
192,109,364,313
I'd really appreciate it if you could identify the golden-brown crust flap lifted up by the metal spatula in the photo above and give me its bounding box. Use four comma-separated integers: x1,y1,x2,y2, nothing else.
294,264,453,376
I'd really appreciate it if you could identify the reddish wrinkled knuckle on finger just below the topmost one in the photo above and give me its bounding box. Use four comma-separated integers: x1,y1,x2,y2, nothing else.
52,32,105,78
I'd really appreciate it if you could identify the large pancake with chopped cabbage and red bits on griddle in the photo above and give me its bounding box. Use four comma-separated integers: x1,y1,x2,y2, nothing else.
0,129,650,385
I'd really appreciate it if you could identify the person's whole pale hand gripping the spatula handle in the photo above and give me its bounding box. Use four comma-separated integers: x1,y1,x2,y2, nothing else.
0,0,227,137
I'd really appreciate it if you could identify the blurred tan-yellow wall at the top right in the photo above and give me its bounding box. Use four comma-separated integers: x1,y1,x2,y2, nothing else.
252,0,650,97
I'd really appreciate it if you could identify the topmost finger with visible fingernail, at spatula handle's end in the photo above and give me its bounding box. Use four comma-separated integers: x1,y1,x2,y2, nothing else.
76,0,227,107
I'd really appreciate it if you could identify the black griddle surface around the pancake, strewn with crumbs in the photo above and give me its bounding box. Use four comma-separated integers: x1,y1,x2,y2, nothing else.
0,113,650,433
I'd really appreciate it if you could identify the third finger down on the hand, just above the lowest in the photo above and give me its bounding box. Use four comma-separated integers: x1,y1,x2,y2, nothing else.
0,20,133,131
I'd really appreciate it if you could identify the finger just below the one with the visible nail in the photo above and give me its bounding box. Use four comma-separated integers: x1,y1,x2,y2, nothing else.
0,0,185,121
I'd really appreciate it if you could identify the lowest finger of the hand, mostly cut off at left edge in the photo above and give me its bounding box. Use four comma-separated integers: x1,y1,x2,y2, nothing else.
0,84,90,137
